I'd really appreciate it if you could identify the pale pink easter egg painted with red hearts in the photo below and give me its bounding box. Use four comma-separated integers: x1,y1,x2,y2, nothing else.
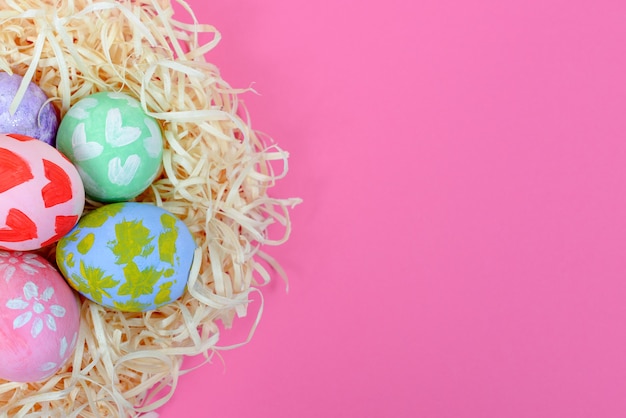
0,134,85,250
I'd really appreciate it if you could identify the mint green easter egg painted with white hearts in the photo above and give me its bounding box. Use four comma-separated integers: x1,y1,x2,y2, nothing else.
57,92,163,202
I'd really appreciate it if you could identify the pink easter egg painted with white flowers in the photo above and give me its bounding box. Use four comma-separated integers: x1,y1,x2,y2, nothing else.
0,251,80,382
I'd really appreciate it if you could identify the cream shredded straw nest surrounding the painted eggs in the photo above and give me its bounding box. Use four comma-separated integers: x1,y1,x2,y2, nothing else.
0,0,298,417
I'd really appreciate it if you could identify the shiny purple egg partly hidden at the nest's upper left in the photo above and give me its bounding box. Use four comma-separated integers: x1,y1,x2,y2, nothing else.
0,72,59,146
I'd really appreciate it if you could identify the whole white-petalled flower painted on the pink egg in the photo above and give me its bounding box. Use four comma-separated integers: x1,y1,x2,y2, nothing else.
6,281,66,338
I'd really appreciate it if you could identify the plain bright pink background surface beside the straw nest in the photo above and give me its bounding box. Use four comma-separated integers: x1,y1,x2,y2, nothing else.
159,0,626,418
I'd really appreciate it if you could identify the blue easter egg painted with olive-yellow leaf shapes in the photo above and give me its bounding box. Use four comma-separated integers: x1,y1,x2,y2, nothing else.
56,202,196,312
